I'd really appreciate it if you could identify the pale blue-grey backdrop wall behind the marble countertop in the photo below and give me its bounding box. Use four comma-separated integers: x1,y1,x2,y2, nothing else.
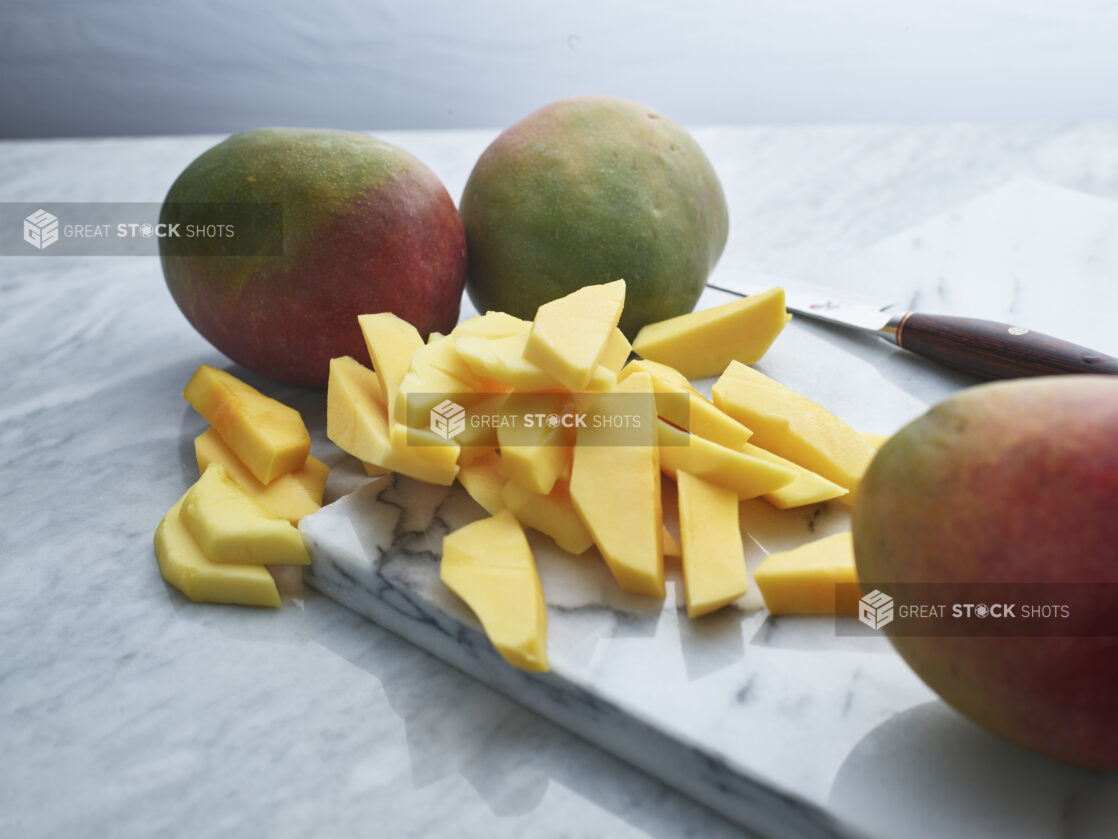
0,0,1118,138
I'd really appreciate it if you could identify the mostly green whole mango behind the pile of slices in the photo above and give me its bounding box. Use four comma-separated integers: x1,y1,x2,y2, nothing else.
461,96,729,340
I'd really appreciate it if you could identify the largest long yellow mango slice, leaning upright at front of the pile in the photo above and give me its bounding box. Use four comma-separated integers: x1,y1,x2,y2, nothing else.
570,373,664,597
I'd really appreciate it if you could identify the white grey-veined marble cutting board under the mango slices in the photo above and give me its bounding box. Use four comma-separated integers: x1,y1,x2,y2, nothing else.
301,180,1118,839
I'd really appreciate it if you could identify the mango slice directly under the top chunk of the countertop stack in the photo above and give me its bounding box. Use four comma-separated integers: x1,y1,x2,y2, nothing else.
195,428,330,525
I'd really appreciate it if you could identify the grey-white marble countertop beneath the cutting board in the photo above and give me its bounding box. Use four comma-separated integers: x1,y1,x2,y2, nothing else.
0,124,1118,839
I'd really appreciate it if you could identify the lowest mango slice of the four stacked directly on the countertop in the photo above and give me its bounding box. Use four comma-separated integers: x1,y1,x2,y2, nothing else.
154,498,280,609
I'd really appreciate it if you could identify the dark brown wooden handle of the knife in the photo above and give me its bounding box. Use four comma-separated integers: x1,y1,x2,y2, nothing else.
896,312,1118,379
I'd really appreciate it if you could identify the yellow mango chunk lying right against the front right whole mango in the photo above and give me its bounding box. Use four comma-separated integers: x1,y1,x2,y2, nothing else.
754,532,858,614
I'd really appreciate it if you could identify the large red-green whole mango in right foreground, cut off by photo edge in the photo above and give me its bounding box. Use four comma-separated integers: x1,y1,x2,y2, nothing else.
853,375,1118,771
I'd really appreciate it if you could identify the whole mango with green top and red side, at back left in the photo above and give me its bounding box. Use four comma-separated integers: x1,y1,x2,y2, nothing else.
160,129,466,388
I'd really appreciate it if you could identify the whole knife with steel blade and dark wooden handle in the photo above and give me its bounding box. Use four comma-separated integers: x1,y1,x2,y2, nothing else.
707,274,1118,379
